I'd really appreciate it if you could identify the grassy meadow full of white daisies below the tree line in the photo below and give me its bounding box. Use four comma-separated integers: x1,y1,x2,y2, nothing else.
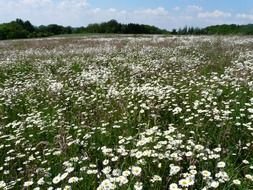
0,36,253,190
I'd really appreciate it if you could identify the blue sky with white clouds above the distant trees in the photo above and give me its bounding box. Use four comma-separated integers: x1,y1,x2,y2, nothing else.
0,0,253,30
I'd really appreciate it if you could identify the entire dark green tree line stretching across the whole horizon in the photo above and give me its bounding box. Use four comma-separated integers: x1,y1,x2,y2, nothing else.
0,19,253,40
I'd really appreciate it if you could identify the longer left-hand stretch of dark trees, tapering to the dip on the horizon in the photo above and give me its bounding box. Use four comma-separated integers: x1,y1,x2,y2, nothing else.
0,19,168,40
